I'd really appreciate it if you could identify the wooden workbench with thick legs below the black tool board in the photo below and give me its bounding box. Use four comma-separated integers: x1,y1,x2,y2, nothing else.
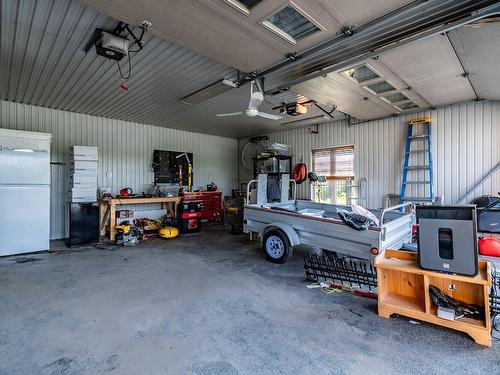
99,197,181,241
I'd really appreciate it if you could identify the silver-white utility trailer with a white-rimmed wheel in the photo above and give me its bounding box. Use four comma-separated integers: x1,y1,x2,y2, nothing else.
243,175,414,263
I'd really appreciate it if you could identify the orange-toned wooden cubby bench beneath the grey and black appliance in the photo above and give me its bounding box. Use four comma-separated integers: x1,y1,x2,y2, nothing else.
375,250,491,346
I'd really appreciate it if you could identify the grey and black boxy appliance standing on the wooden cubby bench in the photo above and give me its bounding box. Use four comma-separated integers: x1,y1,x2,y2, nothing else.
416,205,478,276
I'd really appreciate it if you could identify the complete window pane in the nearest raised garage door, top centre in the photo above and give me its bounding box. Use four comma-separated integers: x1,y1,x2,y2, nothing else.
262,5,321,44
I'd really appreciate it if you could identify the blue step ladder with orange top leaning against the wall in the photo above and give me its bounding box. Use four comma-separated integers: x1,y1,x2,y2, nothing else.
399,117,434,203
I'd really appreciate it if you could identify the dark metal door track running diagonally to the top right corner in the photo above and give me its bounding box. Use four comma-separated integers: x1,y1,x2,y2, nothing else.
236,0,500,92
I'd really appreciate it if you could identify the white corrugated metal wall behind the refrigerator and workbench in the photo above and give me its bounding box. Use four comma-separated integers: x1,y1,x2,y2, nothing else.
0,101,238,239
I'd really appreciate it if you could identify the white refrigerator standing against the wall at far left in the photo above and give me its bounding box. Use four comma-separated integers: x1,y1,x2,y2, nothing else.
0,129,52,256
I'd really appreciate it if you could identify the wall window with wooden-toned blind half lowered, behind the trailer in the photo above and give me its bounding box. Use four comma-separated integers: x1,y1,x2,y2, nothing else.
311,145,354,204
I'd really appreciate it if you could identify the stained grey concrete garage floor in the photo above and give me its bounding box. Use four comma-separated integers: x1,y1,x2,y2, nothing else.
0,226,500,375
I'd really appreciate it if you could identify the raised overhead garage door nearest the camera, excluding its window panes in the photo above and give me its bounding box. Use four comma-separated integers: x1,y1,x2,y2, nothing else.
82,0,412,72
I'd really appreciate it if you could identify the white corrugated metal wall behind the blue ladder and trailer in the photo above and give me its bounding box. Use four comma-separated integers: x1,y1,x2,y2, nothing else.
239,101,500,207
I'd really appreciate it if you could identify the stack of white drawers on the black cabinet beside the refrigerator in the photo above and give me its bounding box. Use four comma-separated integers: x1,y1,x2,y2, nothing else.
69,146,98,203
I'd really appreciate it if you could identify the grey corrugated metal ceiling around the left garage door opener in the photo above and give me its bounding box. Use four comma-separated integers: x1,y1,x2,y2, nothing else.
0,0,304,137
